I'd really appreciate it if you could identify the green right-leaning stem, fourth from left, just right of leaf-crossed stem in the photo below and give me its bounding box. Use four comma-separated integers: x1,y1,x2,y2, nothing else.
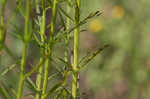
42,0,58,99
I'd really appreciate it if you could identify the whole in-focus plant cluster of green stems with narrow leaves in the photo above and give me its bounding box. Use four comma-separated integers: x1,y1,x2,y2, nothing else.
0,0,108,99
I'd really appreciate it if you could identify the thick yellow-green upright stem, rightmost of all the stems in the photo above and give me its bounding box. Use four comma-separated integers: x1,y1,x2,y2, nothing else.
72,0,80,99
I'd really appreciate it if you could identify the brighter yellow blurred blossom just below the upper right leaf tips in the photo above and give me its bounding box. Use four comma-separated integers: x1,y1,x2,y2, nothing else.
88,19,103,32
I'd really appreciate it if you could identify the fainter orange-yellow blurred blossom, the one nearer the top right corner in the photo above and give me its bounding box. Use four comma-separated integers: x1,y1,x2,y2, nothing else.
112,5,125,19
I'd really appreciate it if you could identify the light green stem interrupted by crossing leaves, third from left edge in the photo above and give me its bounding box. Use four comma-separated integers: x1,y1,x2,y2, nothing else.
36,0,46,99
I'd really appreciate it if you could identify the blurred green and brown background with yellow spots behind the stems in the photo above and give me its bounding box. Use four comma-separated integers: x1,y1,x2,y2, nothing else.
0,0,150,99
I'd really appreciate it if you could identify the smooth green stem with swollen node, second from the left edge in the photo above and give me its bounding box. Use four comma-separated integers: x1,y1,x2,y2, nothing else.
17,0,31,99
